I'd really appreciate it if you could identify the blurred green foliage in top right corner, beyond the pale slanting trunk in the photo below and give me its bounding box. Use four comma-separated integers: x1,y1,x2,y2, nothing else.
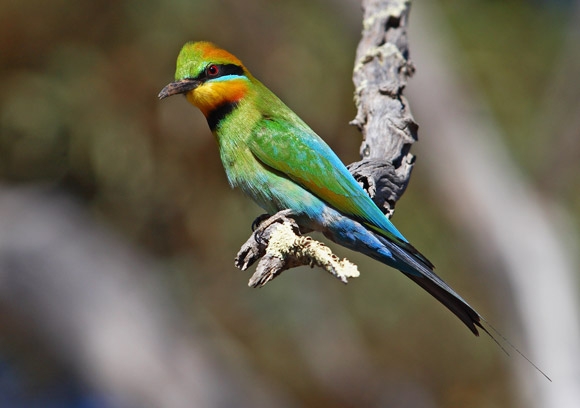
441,0,580,217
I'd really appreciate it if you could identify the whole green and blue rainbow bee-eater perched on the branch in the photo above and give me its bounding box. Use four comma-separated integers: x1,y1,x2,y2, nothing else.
159,42,487,335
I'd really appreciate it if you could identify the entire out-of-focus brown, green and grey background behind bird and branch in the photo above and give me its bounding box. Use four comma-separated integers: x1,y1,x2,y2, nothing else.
0,0,580,408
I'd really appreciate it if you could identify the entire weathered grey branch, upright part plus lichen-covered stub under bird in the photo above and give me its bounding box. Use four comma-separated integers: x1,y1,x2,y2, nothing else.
235,0,417,287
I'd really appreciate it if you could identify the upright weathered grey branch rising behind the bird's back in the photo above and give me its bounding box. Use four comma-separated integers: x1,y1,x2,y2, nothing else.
349,0,418,216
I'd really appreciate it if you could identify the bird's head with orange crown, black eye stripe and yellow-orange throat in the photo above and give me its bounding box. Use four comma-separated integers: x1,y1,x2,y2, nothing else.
159,41,251,117
